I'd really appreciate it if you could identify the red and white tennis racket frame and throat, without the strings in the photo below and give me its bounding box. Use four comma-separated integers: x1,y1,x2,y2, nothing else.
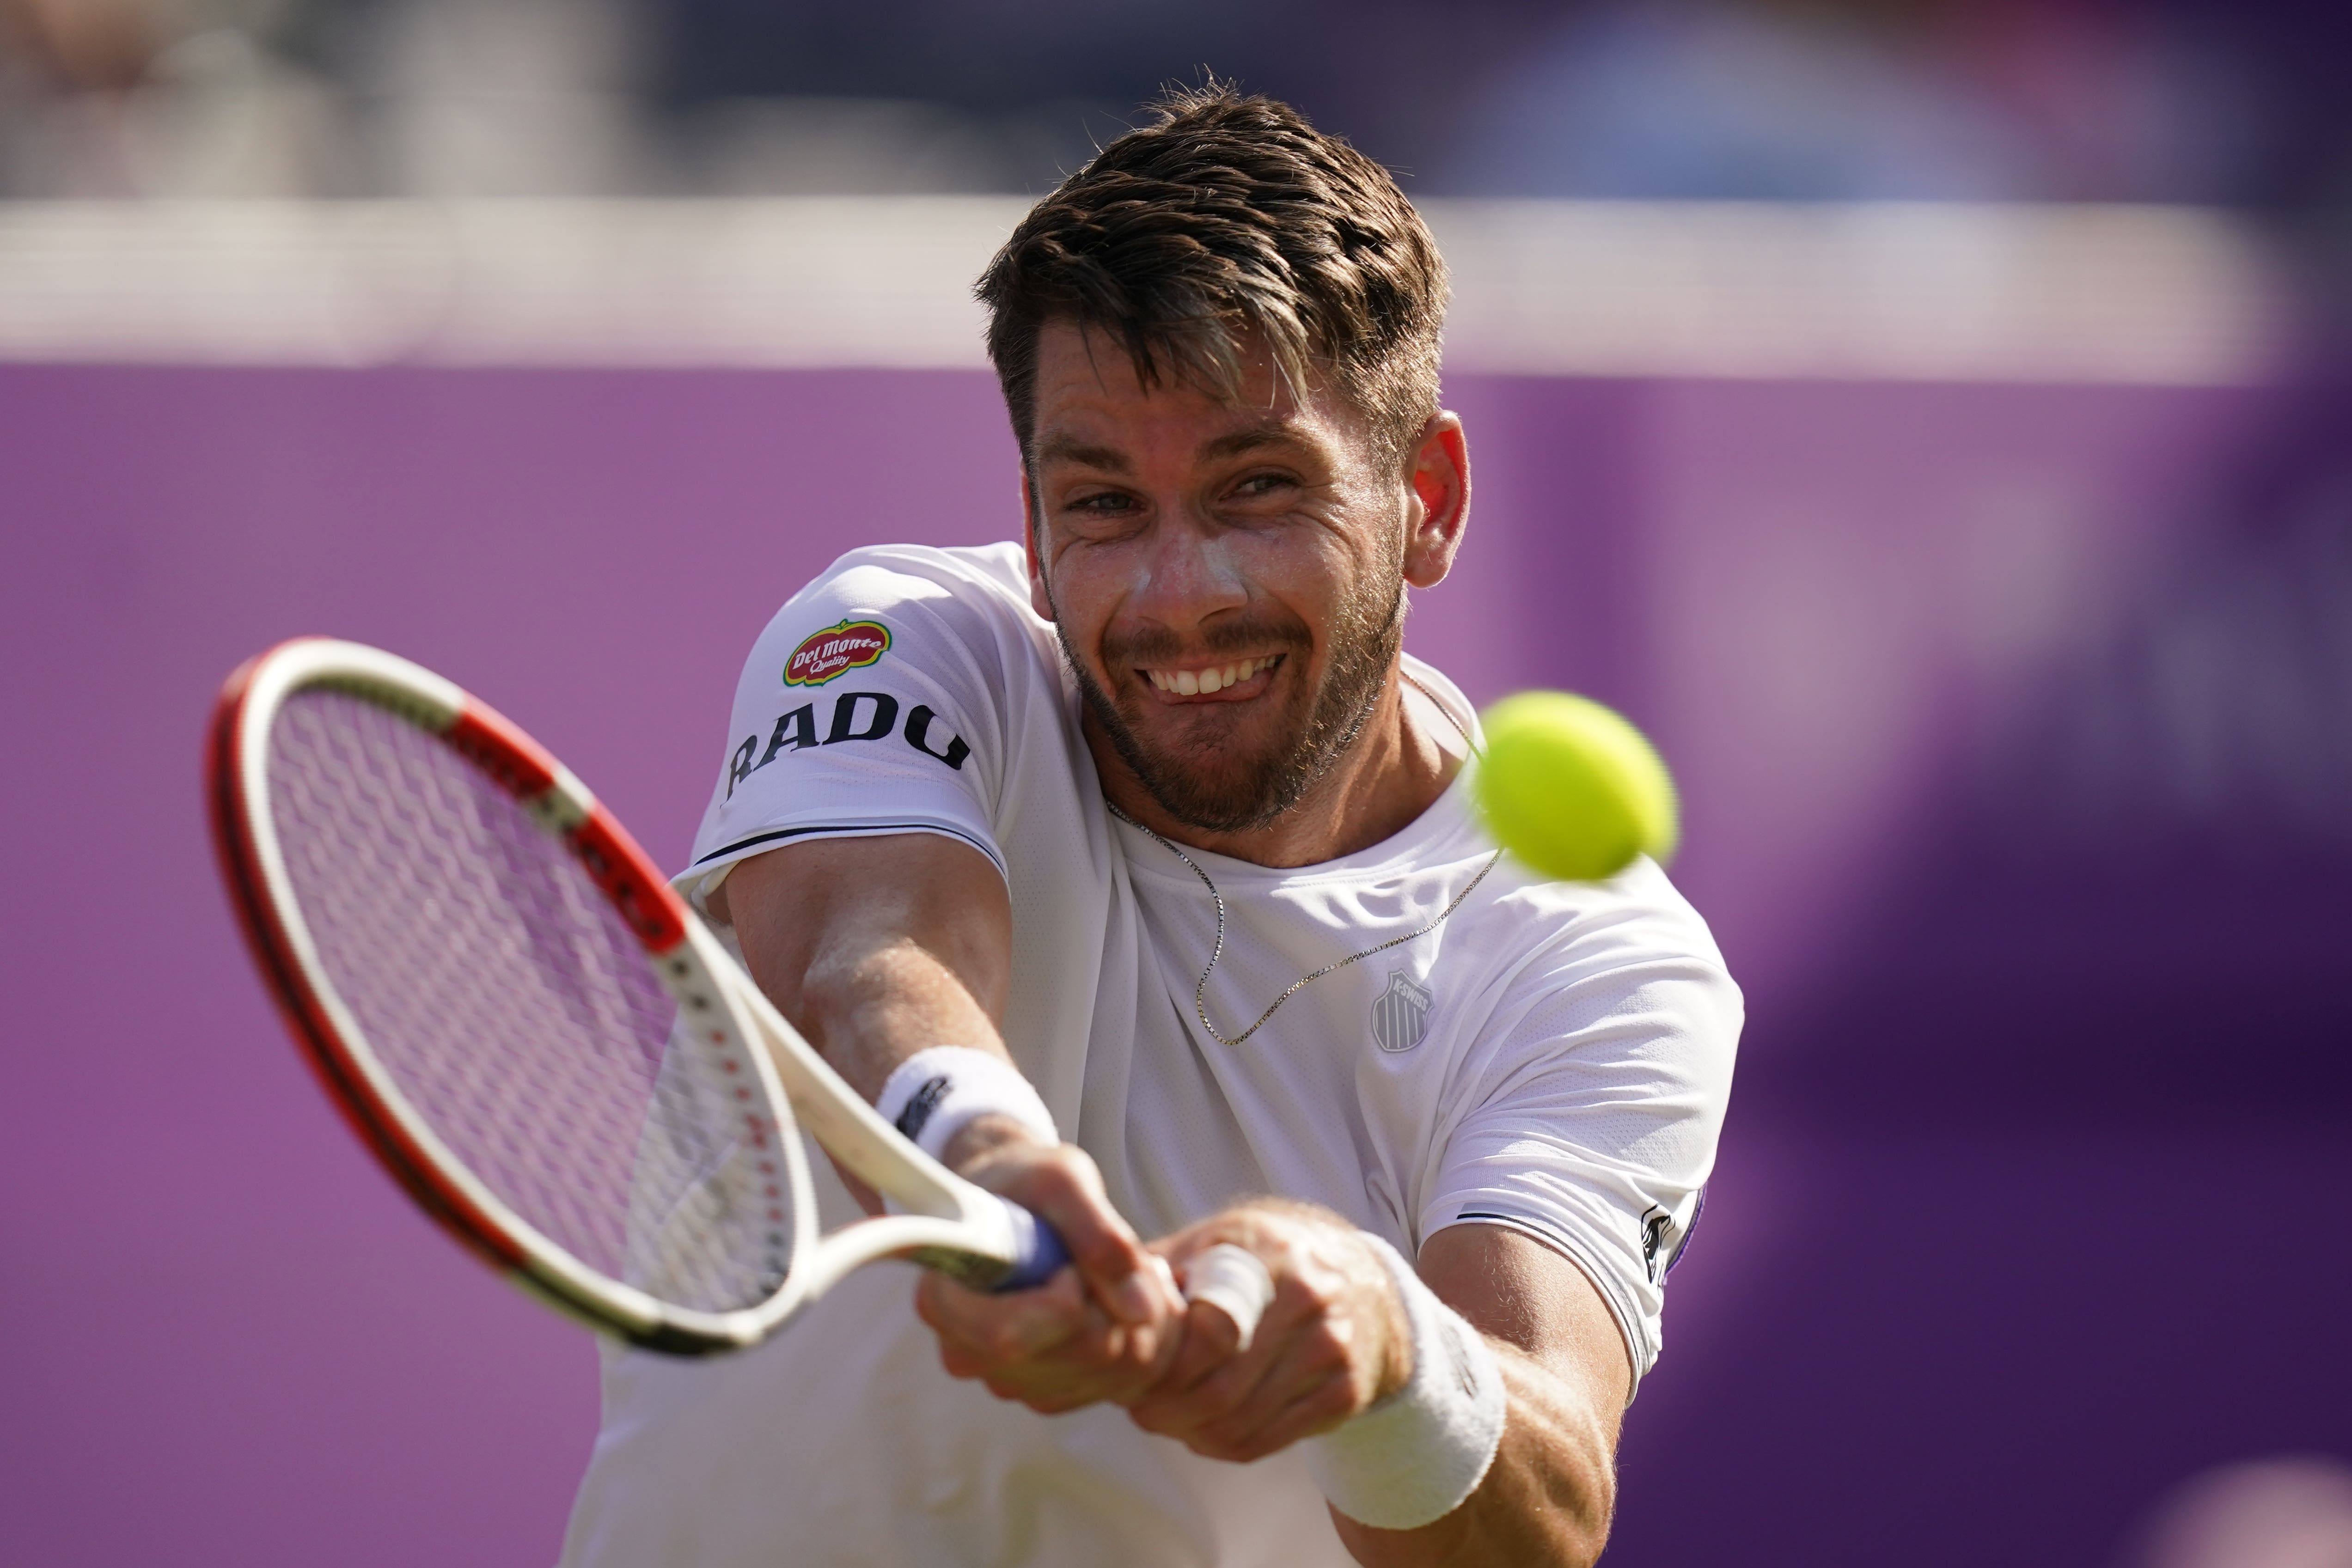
207,637,1039,1356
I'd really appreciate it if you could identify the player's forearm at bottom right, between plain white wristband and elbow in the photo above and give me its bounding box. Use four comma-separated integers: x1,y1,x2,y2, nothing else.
1331,1335,1616,1568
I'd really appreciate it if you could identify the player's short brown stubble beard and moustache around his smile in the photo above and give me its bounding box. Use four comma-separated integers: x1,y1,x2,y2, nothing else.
1049,574,1404,832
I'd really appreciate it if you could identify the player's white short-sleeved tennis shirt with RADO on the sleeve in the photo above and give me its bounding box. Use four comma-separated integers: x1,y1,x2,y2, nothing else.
564,545,1741,1568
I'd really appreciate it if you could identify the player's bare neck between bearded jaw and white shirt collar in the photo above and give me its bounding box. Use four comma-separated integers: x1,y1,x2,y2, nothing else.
1082,660,1460,867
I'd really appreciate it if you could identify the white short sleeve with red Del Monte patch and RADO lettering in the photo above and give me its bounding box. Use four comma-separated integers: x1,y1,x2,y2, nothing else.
678,545,1039,903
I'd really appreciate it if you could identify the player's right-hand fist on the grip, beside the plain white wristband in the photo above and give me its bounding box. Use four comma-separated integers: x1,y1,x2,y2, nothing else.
1129,1201,1413,1462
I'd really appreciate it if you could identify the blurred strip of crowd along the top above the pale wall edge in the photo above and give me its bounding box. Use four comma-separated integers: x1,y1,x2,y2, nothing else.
0,0,2352,209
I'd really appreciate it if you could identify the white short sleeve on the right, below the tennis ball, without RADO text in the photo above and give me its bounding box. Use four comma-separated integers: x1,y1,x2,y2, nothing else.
1421,874,1741,1382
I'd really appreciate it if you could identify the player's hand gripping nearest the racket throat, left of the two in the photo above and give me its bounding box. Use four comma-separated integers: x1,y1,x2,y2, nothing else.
915,1117,1183,1415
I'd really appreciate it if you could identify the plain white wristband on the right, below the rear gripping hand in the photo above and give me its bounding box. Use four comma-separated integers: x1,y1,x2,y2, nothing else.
1303,1232,1503,1531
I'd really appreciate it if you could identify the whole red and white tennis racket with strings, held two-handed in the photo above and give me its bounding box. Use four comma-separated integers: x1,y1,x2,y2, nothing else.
209,637,1272,1356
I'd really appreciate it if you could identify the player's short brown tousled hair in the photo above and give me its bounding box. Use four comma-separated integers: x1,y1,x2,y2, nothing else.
976,80,1447,456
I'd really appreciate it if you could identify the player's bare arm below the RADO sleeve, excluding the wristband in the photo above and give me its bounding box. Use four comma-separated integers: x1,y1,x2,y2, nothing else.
710,832,1167,1356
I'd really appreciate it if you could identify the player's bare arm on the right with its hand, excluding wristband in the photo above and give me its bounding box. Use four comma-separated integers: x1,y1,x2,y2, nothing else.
1134,1204,1632,1568
